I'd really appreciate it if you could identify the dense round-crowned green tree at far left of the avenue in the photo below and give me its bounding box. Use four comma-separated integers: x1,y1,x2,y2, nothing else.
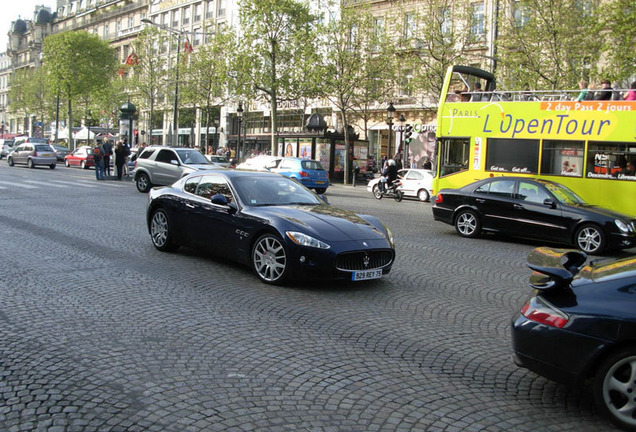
43,31,116,149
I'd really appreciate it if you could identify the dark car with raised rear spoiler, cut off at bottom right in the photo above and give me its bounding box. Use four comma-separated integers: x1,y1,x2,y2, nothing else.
512,248,636,430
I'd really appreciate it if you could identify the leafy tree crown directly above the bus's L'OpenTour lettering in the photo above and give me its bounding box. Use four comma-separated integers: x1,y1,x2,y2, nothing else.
497,0,600,90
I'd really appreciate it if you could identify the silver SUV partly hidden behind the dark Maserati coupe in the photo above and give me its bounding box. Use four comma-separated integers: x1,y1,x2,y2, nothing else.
134,146,222,192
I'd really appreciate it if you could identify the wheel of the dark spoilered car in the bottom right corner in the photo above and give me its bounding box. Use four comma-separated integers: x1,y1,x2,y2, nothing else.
594,347,636,431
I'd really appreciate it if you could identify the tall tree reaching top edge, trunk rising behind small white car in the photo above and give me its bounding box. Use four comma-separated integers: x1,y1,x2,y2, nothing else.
235,0,317,154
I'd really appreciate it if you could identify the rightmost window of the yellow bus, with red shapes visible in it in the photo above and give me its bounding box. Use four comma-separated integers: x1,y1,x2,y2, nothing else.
586,142,636,181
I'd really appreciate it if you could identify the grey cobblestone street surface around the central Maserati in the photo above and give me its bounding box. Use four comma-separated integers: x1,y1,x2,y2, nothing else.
0,163,634,432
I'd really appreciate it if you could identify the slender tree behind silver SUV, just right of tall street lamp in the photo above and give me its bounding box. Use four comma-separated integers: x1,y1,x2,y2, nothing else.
181,28,237,151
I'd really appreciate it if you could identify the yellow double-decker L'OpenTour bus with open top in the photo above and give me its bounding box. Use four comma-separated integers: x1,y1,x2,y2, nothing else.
433,66,636,216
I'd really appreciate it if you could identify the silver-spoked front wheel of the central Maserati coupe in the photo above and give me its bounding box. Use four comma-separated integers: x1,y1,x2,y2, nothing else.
252,234,288,284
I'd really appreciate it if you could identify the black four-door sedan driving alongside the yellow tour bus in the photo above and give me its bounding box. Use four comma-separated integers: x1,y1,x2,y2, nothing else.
433,177,636,255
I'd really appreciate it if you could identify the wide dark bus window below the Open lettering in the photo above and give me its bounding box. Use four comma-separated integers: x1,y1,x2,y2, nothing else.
486,138,539,174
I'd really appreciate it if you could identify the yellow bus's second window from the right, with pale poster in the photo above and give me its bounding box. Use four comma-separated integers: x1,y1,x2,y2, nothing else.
541,140,585,177
